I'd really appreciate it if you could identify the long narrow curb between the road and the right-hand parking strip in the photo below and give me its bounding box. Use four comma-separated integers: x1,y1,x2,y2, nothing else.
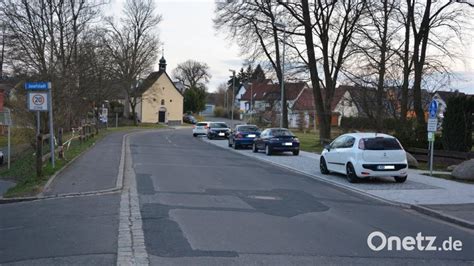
199,138,474,229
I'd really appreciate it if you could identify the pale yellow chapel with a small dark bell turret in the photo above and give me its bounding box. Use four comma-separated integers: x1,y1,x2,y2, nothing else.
136,57,184,125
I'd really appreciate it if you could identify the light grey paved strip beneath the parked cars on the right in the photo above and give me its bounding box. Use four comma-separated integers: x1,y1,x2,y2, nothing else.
202,138,474,228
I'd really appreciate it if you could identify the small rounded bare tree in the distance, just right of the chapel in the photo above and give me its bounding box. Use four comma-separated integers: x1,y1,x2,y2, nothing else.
173,60,212,89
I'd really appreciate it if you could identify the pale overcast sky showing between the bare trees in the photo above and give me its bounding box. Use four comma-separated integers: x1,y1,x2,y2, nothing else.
109,0,474,94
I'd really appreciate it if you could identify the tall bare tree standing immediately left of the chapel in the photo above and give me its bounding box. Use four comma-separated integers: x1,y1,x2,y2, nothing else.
106,0,161,125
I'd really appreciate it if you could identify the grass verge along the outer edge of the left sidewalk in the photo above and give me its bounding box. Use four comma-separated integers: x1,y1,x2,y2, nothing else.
0,124,166,198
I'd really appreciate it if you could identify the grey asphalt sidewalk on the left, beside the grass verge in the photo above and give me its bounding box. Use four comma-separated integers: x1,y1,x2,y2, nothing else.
43,131,130,196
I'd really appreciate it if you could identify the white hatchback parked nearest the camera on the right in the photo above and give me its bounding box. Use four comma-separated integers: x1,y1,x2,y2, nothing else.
319,133,408,183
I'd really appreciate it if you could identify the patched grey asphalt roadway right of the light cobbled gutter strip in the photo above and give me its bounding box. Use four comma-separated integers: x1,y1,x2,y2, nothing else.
130,129,474,265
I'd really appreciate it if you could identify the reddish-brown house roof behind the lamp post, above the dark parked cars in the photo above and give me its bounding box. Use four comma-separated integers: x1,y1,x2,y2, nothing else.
241,82,307,101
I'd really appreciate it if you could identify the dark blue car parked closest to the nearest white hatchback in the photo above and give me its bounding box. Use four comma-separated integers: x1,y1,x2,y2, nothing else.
252,128,300,155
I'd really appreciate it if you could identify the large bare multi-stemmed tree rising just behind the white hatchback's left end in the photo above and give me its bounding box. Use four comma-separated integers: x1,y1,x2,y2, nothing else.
280,0,366,141
